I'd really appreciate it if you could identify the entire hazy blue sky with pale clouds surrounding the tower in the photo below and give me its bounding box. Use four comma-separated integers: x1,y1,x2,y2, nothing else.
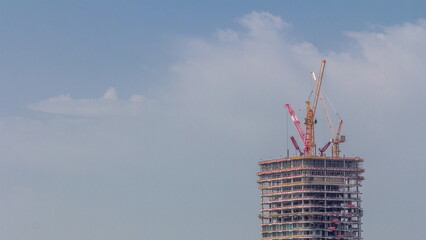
0,0,426,240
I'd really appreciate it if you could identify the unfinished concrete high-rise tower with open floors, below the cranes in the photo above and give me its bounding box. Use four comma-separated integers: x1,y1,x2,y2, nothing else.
257,156,364,240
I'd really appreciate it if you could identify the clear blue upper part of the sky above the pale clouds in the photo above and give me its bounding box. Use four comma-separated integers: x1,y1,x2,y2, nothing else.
0,0,425,114
